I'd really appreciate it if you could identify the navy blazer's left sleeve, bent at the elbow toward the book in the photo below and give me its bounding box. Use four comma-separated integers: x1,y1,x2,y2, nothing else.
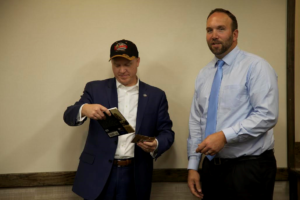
64,83,93,126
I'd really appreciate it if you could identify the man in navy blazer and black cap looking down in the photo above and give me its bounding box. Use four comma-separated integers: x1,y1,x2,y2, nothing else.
64,40,174,200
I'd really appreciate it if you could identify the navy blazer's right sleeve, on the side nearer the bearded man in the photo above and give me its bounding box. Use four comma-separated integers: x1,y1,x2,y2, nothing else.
155,92,174,159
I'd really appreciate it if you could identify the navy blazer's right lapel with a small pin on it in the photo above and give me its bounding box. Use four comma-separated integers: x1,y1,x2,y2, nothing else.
135,81,149,133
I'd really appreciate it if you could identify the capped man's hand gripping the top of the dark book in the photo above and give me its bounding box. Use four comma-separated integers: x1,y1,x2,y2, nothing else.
81,104,111,120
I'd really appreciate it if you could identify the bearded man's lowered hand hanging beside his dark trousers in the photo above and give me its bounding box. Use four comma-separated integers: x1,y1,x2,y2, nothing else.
188,169,203,199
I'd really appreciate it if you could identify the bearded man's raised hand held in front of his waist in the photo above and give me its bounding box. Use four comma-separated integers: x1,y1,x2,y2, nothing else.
196,131,226,156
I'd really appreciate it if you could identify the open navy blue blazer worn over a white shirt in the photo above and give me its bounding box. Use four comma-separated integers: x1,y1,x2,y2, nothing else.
64,78,174,200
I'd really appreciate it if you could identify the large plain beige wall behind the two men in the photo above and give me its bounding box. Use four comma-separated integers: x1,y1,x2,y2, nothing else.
0,0,287,174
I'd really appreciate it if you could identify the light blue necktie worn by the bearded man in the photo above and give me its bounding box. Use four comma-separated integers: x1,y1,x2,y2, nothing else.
205,60,224,160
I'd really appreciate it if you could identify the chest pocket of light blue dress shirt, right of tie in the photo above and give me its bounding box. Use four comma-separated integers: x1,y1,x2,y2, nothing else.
219,85,248,109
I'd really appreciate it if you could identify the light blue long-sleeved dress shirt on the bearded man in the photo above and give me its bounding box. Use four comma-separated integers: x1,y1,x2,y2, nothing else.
187,47,278,170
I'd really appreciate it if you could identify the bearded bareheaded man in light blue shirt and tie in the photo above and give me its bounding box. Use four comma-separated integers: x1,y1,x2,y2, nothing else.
188,9,278,200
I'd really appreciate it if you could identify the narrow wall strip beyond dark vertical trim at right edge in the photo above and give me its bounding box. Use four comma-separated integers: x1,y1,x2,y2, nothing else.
295,0,300,142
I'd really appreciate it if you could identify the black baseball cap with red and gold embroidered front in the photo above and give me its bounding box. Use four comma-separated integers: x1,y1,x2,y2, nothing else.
109,39,139,60
